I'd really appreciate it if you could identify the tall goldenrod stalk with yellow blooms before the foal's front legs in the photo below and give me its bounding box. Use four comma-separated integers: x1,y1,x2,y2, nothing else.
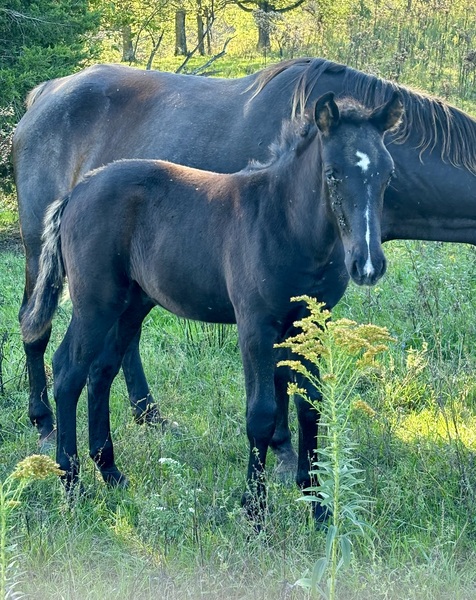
279,296,394,600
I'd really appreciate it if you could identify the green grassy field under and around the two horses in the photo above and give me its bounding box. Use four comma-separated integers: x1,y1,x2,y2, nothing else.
0,191,476,600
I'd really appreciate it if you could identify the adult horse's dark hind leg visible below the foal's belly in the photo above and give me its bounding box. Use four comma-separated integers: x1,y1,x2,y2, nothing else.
122,327,165,424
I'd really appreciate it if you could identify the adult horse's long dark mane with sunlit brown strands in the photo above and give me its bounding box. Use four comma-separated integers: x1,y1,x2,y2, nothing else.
252,58,476,175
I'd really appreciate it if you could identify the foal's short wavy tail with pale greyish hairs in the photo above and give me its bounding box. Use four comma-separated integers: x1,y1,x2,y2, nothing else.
21,195,70,343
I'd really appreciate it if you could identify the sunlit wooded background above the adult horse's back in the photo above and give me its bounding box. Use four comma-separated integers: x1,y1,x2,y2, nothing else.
0,0,476,123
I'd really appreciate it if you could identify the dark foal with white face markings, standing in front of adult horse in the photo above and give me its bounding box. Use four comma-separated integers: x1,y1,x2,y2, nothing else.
22,92,403,513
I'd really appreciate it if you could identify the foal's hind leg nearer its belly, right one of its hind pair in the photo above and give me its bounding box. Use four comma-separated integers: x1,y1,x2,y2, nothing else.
88,297,153,486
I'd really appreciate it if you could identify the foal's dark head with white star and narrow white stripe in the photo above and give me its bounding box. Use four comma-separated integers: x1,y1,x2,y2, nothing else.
315,92,403,285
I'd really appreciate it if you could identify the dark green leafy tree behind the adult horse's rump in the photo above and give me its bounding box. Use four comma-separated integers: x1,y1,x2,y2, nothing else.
0,0,99,187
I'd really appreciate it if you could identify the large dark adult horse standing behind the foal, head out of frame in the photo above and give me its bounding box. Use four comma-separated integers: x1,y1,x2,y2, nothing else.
13,58,476,462
